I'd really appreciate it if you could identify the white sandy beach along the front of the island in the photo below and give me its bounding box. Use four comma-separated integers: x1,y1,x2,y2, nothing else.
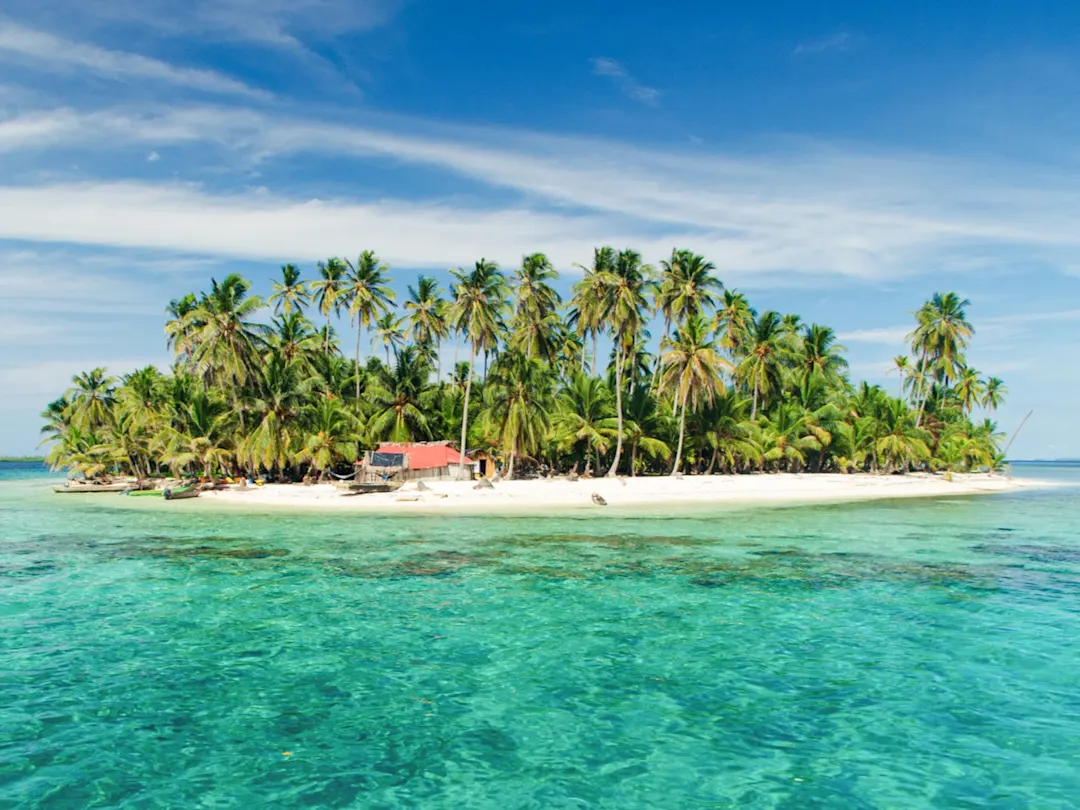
187,474,1048,515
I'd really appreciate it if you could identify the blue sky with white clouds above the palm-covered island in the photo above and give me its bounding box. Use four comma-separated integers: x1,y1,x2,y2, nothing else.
0,0,1080,457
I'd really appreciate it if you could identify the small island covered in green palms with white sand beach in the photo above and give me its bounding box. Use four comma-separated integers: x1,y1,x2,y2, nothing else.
42,247,1019,505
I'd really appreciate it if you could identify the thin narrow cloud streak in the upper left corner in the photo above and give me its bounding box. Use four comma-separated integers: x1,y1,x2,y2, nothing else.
0,19,270,98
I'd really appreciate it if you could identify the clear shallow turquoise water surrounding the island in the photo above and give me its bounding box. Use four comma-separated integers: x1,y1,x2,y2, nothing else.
0,469,1080,810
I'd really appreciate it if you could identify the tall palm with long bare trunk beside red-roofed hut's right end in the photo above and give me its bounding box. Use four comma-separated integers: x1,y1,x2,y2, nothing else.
450,259,507,477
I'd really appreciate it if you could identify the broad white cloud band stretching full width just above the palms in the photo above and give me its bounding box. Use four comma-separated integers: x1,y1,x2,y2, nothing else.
10,107,1080,283
